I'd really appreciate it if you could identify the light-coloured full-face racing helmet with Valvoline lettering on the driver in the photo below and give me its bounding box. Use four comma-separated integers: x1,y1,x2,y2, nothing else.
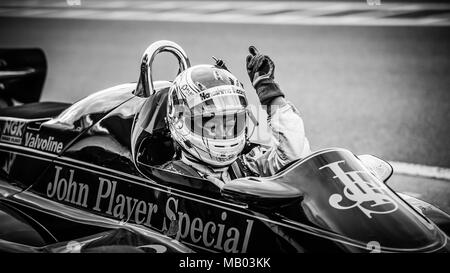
167,65,248,167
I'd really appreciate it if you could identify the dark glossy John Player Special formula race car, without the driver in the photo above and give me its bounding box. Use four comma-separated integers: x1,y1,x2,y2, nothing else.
0,41,450,253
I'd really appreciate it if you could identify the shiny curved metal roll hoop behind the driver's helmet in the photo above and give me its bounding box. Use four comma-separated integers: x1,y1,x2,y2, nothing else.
134,40,191,98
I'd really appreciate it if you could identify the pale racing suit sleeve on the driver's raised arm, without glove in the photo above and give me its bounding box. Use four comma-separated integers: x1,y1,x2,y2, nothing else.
240,102,311,176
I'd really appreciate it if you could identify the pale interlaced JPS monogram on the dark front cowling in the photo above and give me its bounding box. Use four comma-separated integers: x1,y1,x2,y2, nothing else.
319,160,398,218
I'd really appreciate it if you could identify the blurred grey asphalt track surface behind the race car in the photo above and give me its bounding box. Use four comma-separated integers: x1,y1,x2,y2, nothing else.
0,1,450,212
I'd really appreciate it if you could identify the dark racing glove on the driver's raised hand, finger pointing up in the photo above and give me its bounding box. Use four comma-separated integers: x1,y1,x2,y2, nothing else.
246,46,284,105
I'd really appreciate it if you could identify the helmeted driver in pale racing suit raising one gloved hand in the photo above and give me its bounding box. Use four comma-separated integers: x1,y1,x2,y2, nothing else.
162,46,310,186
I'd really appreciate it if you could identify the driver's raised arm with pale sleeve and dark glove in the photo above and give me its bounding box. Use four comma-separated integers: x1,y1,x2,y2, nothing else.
240,47,310,176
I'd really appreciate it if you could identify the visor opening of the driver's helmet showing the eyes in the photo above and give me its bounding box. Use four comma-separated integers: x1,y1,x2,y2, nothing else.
185,110,246,139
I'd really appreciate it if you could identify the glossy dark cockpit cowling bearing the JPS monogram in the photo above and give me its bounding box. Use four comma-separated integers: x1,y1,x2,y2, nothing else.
275,149,443,251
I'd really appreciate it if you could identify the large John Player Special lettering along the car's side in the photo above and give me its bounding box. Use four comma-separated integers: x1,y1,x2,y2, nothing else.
46,166,254,253
